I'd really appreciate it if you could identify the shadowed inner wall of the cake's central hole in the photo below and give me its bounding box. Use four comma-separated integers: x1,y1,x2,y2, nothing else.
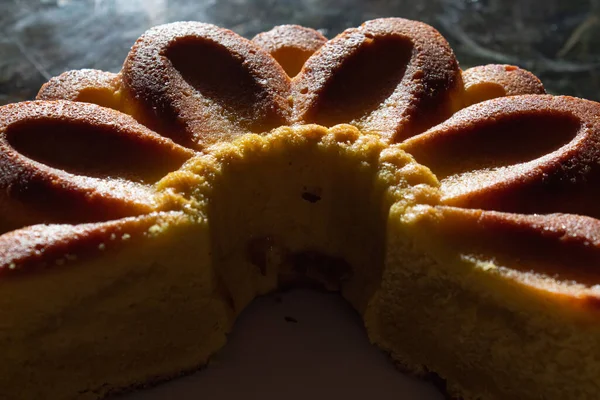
207,125,396,311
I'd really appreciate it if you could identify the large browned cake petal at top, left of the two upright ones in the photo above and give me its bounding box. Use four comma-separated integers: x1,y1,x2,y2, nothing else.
122,22,290,149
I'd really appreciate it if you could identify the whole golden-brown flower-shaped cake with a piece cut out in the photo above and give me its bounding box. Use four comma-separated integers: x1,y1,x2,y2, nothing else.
0,18,600,400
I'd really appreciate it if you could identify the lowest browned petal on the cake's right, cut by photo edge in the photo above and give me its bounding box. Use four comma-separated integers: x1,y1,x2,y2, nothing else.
418,206,600,287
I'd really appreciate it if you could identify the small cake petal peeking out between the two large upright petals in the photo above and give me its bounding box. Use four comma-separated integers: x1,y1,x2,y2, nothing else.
252,25,327,77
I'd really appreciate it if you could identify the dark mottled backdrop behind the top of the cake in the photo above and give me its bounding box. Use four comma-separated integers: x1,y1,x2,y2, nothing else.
0,0,600,104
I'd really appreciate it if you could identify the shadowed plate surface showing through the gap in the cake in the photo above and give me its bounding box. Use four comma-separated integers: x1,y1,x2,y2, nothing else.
123,289,444,400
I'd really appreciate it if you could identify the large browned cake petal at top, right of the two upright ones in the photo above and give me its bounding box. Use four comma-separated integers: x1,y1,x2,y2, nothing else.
292,18,463,142
